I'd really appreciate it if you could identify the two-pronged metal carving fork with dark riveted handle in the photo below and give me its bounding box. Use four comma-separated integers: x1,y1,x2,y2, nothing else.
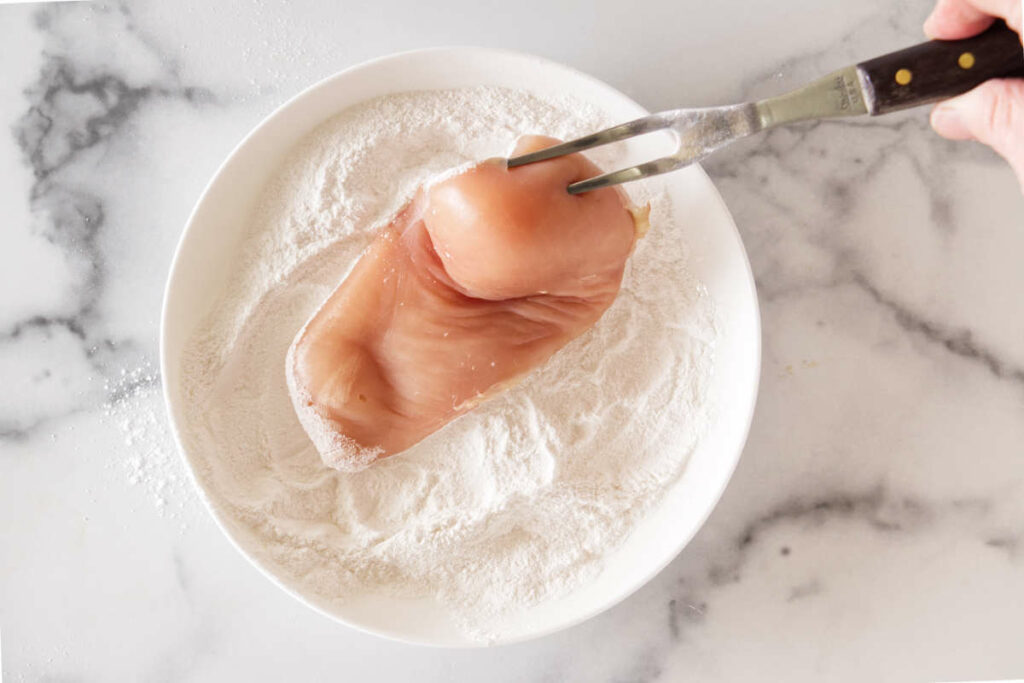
508,22,1024,195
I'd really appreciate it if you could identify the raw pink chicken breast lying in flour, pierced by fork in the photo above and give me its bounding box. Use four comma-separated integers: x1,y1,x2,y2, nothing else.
287,136,646,470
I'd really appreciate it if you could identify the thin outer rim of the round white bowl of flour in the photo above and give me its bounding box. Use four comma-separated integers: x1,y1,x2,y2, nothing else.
160,45,762,650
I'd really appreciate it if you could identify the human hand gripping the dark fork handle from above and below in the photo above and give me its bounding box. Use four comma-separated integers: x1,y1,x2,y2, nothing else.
925,0,1024,190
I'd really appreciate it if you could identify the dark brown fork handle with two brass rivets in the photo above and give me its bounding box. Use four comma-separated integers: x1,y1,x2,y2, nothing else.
857,20,1024,116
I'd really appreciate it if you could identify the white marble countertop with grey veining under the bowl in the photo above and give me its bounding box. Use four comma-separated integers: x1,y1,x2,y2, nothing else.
0,0,1024,682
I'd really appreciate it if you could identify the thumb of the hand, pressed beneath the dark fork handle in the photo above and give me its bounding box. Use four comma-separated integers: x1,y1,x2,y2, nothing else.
932,79,1024,186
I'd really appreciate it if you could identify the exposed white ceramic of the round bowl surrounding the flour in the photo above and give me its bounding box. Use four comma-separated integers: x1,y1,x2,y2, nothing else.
160,47,761,646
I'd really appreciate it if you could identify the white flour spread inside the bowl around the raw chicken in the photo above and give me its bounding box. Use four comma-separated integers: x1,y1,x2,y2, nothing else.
182,88,715,640
